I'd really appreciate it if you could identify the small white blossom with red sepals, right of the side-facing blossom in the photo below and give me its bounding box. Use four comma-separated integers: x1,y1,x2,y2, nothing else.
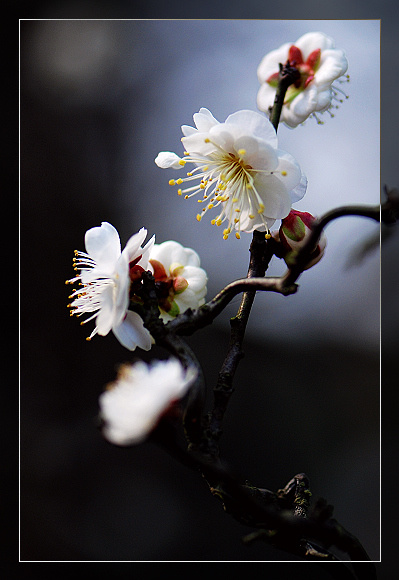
149,240,208,322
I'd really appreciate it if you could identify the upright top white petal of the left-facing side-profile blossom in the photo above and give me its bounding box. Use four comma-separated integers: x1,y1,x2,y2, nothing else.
85,222,121,272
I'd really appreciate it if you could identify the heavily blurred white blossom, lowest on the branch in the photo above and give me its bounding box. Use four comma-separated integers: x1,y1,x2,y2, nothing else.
99,359,197,445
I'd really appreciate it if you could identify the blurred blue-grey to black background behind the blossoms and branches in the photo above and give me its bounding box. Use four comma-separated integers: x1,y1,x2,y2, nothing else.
20,3,399,578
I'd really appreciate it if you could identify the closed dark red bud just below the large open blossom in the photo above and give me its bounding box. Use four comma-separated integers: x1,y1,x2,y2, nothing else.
278,210,327,270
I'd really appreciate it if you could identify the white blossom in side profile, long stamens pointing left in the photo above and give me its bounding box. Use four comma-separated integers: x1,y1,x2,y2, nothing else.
67,222,155,350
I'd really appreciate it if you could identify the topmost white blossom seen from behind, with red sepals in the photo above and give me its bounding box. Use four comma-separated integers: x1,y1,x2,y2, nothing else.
257,32,349,128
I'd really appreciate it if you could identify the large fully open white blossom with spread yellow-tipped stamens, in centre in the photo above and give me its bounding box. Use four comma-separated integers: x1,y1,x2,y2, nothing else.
155,108,306,239
